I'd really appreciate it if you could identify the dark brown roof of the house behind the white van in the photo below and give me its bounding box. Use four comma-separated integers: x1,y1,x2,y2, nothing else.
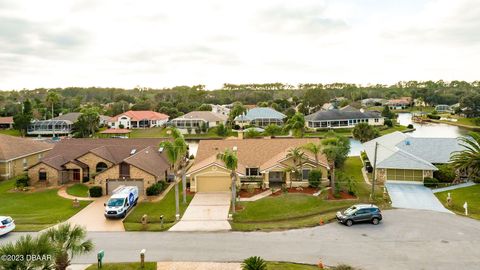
41,138,162,170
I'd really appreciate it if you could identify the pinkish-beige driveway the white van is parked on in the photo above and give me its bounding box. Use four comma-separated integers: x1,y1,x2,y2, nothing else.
67,196,125,232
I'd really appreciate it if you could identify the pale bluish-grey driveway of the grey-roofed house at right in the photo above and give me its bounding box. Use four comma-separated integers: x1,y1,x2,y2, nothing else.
385,182,451,213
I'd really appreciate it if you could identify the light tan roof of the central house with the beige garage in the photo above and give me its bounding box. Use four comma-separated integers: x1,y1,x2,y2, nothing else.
188,138,327,174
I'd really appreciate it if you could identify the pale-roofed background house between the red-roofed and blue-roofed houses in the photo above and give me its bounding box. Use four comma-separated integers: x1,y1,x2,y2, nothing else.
170,111,228,132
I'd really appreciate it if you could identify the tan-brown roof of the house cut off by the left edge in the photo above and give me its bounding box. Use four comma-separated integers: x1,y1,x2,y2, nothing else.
0,135,53,161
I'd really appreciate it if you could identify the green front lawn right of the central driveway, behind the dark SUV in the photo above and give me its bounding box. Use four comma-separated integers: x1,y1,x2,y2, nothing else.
231,157,388,231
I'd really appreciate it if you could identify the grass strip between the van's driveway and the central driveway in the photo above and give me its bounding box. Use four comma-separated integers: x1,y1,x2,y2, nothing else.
123,187,193,231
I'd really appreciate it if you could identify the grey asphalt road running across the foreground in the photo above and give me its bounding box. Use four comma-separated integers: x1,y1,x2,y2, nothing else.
0,209,480,270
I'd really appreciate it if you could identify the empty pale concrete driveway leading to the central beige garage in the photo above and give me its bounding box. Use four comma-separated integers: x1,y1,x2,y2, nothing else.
170,192,232,232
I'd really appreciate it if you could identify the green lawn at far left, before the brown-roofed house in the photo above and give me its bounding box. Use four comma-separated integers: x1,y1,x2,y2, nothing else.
0,179,89,231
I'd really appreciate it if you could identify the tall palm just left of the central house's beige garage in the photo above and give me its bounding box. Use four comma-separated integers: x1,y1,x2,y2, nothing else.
160,128,188,220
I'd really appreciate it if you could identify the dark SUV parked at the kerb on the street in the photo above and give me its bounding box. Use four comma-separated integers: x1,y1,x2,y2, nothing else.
337,204,382,227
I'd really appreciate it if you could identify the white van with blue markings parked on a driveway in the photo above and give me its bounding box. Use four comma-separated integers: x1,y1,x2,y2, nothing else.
104,186,138,218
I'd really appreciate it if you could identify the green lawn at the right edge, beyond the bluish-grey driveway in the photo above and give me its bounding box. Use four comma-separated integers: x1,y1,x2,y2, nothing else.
435,185,480,219
